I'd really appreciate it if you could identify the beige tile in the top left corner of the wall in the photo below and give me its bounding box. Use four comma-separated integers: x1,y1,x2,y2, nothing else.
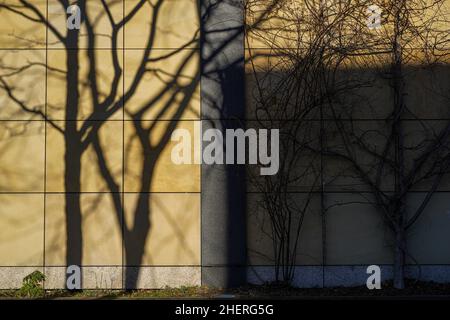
0,0,47,48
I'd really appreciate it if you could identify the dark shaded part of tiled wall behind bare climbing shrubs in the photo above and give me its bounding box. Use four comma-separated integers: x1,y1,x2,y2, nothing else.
246,59,450,287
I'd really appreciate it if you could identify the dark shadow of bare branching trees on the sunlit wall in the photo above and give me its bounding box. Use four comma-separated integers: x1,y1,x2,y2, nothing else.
0,0,278,288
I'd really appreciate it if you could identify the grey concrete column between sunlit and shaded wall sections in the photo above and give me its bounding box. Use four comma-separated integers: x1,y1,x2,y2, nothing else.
201,0,247,288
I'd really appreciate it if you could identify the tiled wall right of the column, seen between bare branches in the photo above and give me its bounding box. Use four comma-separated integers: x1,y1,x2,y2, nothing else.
245,1,450,276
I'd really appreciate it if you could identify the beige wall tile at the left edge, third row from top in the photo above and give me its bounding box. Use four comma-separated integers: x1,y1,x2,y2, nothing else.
0,121,45,192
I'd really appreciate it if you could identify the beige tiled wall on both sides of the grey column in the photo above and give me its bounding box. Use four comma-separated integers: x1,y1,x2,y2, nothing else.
0,0,450,288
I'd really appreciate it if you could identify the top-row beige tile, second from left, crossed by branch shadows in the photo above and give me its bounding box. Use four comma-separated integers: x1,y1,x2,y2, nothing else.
48,0,123,49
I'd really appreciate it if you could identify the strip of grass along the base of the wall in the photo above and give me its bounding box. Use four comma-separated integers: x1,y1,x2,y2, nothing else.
0,280,450,299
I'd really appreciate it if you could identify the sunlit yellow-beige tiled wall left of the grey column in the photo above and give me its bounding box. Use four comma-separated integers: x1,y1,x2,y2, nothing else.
0,0,200,288
